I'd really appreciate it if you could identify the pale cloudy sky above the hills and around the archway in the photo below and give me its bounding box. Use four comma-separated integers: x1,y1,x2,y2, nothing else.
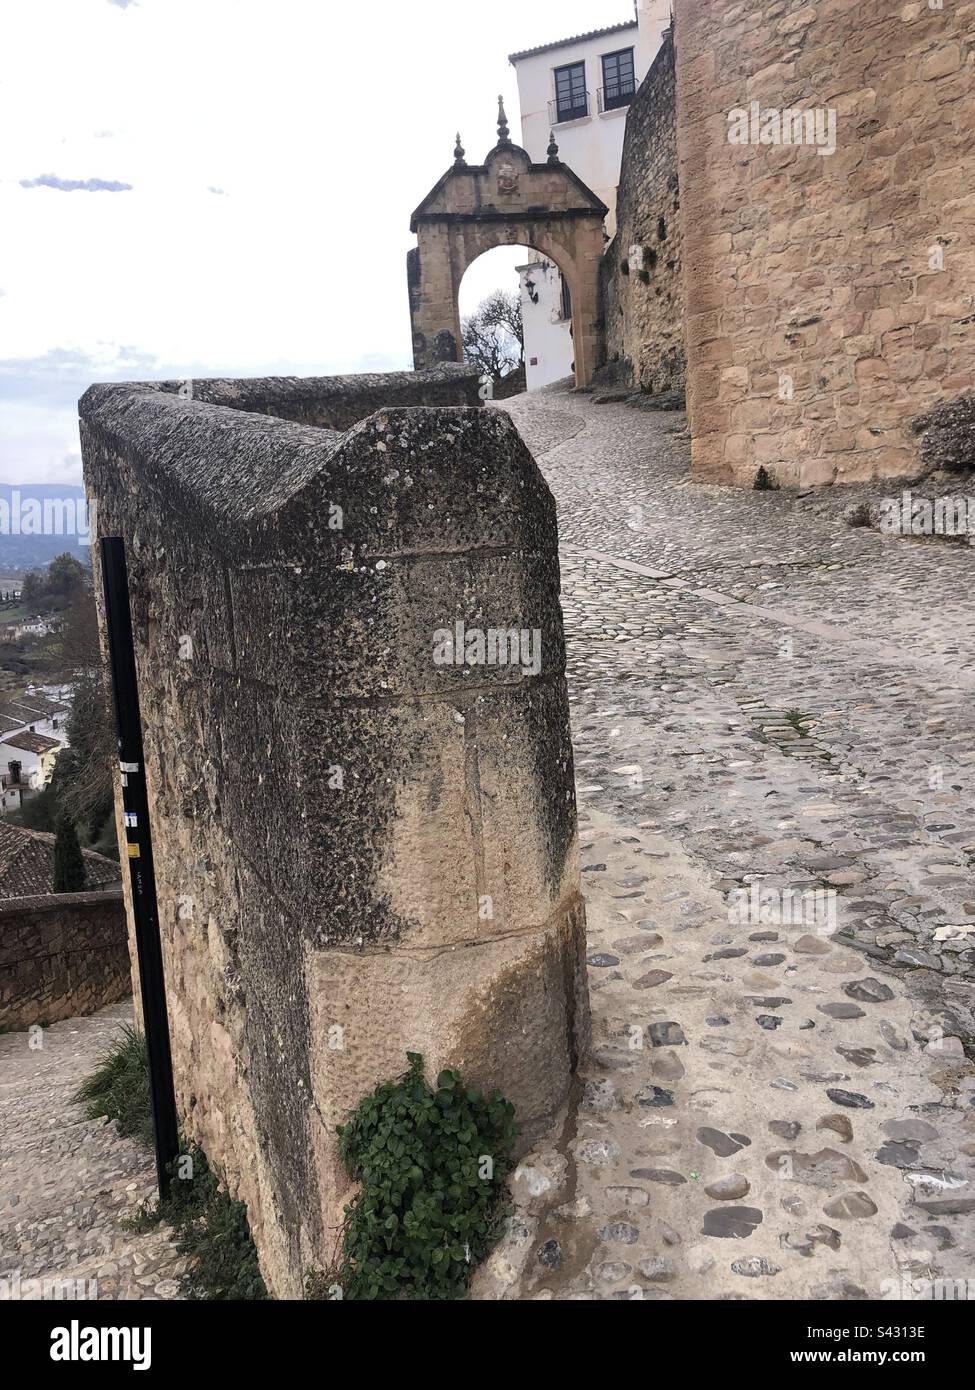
0,0,633,482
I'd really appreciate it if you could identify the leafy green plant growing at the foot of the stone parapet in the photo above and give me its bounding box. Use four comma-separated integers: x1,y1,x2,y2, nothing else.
338,1052,519,1300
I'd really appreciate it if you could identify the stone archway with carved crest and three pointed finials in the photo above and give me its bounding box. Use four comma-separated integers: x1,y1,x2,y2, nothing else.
406,99,608,386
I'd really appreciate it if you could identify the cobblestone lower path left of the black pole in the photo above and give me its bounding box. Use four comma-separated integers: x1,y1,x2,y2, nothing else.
0,1002,181,1300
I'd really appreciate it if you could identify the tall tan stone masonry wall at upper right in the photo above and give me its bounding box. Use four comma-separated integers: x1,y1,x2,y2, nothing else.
676,0,975,485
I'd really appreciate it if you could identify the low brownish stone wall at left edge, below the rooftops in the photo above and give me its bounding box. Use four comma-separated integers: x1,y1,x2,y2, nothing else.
0,888,132,1029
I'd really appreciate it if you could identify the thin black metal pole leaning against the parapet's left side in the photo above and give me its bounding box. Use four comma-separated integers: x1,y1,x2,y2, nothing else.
99,535,179,1200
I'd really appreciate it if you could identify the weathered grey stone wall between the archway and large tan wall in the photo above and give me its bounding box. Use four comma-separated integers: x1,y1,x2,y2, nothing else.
599,31,684,395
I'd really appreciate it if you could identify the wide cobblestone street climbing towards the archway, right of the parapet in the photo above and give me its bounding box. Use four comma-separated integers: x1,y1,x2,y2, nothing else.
478,388,975,1298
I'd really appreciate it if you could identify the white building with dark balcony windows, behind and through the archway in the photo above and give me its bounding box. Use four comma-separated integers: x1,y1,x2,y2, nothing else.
509,0,670,391
